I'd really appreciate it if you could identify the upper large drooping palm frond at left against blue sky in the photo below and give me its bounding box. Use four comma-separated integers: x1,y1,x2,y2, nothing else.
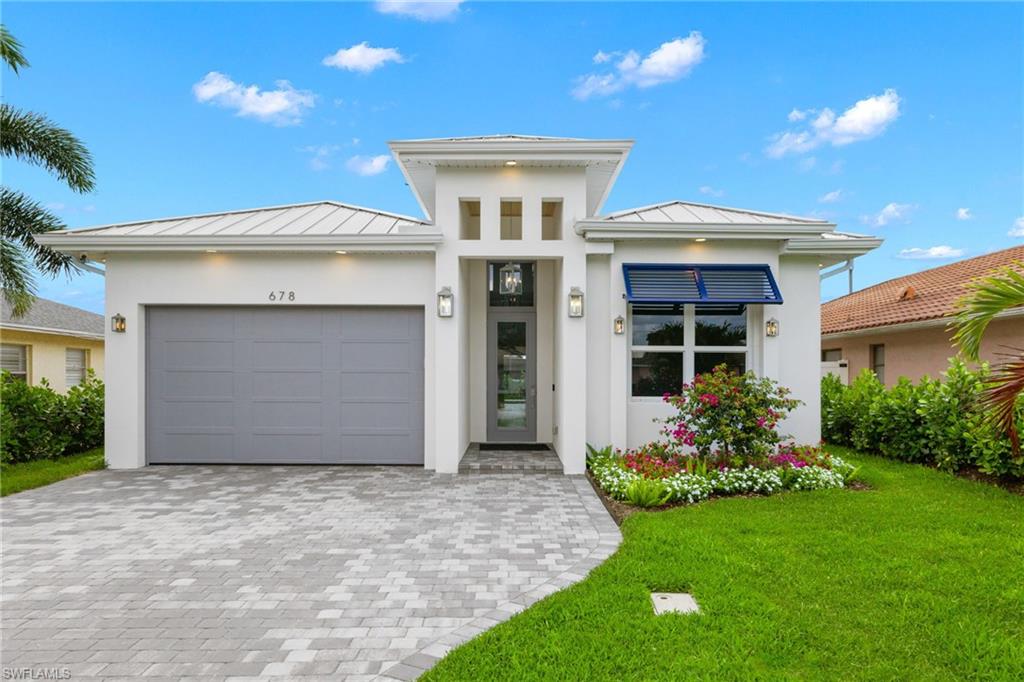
0,103,95,193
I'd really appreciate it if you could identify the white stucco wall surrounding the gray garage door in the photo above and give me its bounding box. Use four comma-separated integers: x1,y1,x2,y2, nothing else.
105,253,436,469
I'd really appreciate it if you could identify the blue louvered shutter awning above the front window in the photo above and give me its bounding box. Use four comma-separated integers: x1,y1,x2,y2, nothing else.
623,263,782,304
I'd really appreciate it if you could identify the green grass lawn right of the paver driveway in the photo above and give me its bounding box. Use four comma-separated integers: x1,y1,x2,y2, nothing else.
423,447,1024,680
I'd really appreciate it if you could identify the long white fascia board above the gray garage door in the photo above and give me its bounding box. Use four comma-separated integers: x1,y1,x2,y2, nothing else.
30,232,443,253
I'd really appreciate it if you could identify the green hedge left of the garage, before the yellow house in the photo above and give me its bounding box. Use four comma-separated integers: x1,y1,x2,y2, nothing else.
0,372,103,463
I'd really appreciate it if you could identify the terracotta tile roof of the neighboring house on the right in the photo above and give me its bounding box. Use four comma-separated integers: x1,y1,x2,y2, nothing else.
821,245,1024,334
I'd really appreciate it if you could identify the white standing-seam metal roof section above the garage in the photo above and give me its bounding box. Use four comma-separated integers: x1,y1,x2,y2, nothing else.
59,202,430,237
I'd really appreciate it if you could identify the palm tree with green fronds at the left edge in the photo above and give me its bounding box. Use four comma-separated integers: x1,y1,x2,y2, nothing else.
0,25,95,316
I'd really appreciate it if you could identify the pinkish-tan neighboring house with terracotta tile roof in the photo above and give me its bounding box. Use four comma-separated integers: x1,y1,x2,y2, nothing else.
821,246,1024,386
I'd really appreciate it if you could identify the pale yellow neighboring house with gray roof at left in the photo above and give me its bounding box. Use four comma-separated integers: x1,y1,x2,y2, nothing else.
0,298,103,393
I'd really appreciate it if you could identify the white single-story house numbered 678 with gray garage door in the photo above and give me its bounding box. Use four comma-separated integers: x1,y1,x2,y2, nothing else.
38,135,880,474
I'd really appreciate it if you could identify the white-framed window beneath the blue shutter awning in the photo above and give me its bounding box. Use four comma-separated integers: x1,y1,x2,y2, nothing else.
630,303,750,397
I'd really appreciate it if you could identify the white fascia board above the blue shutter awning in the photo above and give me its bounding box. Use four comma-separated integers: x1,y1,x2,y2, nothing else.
575,220,827,241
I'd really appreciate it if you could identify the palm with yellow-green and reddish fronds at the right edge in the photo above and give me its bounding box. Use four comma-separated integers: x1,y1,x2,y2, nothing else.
953,261,1024,456
